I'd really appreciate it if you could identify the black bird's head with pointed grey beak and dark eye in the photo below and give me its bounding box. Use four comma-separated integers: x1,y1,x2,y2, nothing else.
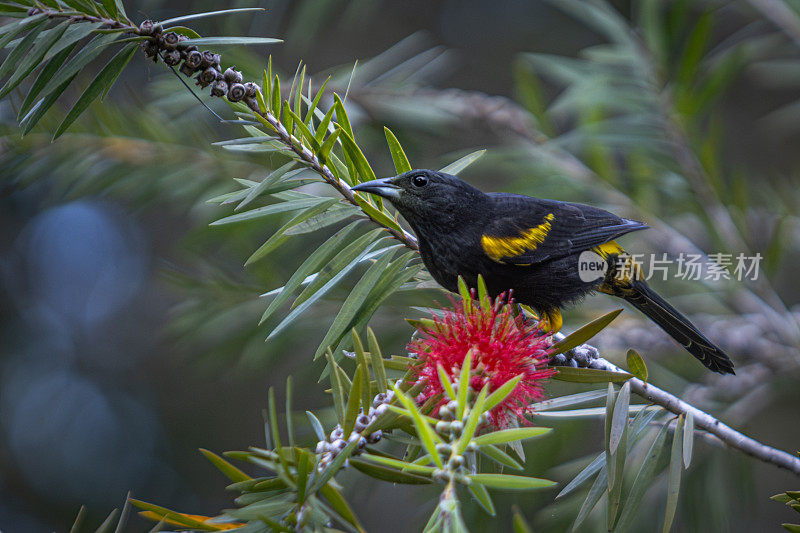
353,169,488,230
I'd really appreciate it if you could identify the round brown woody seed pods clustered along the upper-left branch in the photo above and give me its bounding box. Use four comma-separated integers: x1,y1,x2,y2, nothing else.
139,20,260,102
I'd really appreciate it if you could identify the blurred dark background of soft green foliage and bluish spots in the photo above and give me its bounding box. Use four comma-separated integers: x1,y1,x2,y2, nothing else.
0,0,800,532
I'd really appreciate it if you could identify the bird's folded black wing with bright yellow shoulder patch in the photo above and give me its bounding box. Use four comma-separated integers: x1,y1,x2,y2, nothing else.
481,193,647,265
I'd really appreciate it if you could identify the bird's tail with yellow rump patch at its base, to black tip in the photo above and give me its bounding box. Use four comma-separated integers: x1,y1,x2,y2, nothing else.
595,241,735,374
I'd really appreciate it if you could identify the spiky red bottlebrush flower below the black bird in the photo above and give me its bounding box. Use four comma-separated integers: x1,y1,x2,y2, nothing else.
408,295,555,427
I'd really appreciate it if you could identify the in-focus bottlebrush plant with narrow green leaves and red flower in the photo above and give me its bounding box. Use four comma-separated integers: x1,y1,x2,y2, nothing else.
0,0,800,532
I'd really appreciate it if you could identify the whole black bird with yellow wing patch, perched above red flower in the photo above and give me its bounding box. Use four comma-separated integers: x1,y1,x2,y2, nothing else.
353,170,734,374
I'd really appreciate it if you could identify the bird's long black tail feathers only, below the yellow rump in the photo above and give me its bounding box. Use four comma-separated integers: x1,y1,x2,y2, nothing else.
617,280,734,374
